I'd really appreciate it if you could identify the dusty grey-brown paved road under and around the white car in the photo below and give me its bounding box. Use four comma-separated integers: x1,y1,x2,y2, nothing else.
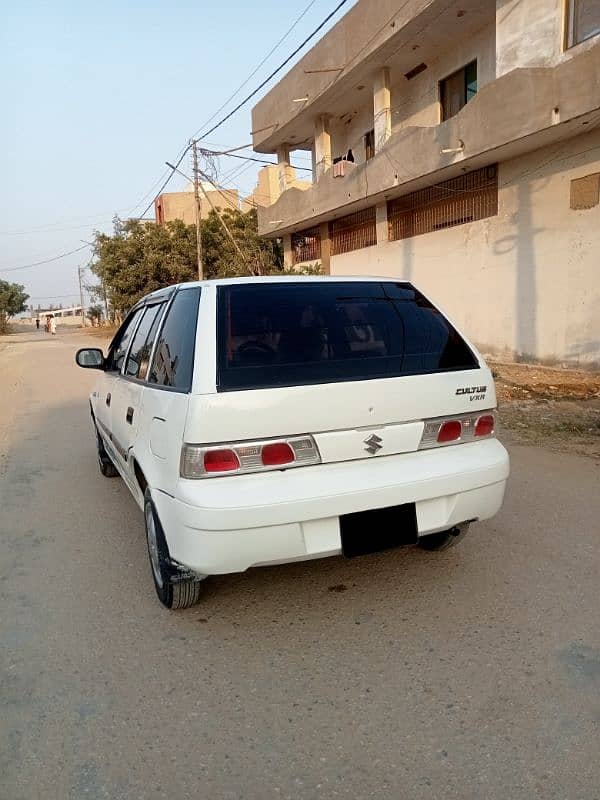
0,333,600,800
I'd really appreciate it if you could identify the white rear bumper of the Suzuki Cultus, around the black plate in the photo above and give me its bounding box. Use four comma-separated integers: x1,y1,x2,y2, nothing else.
153,439,509,575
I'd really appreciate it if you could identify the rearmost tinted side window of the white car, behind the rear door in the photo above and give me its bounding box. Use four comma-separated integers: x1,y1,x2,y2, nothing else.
148,289,200,392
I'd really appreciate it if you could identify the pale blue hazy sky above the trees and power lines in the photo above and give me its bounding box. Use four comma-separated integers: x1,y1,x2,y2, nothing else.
0,0,355,307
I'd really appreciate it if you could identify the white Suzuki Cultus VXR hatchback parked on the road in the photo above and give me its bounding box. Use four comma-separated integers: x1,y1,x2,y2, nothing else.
76,276,509,608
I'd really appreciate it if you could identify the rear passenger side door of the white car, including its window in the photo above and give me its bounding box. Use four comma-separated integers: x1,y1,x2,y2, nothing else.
111,301,165,493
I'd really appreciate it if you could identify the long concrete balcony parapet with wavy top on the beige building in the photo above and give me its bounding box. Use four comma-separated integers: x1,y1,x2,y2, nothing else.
258,41,600,237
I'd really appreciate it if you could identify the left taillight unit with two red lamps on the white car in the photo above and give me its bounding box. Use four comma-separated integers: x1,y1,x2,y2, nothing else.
180,435,321,479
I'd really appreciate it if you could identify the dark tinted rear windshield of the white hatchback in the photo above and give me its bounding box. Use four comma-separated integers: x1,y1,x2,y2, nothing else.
217,281,478,391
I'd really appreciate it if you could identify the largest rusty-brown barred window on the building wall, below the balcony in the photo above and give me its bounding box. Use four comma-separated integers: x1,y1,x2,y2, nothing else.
387,164,498,241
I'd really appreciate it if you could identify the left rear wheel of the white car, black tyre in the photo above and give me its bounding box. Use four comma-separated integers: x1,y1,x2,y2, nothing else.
144,489,202,609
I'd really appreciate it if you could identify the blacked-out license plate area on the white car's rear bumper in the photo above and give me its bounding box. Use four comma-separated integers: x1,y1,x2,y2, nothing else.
340,503,419,558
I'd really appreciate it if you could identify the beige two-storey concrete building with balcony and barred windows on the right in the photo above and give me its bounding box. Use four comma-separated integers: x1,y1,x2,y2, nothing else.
252,0,600,364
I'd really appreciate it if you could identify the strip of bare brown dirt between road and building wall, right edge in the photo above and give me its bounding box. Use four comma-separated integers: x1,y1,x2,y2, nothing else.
488,359,600,458
